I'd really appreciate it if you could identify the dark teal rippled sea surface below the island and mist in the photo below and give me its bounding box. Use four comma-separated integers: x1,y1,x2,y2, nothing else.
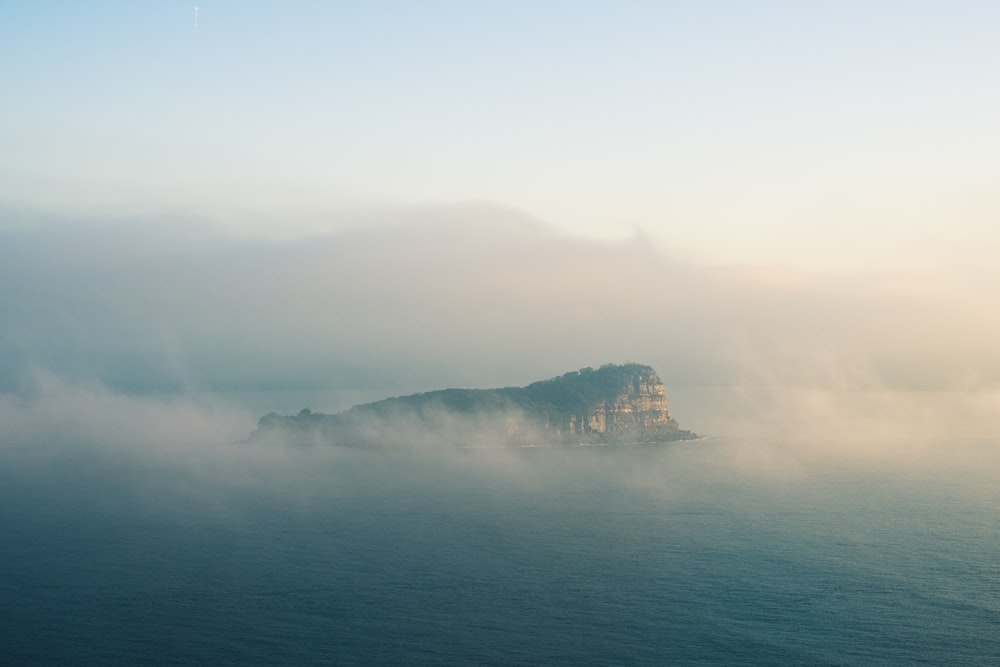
0,440,1000,665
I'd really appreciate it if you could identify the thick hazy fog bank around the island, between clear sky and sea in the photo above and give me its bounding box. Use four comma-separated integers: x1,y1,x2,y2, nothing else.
0,205,1000,477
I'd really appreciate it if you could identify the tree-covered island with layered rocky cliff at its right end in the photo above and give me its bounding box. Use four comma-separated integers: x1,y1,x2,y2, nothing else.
251,364,698,446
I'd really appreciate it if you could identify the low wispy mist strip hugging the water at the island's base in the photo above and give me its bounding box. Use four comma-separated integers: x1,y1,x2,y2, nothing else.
0,378,1000,508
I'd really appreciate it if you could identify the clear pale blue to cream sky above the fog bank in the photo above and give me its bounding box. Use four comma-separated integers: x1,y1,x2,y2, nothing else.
0,0,1000,268
